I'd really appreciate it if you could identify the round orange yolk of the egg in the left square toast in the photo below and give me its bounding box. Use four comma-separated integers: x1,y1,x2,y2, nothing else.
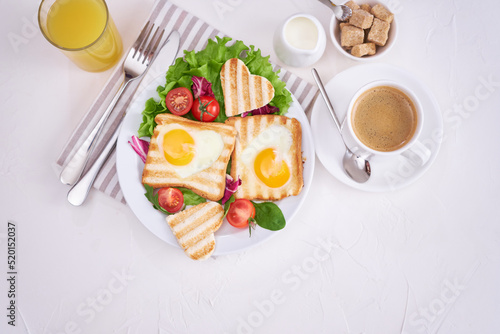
163,129,194,166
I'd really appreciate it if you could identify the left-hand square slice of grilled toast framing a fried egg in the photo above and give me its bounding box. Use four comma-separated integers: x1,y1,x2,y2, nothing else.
142,114,236,201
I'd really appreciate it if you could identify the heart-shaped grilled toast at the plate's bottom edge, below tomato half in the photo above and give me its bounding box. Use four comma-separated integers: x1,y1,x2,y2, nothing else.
167,202,224,260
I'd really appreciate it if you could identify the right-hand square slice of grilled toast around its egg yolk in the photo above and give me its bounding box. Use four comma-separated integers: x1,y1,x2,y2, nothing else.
226,115,304,200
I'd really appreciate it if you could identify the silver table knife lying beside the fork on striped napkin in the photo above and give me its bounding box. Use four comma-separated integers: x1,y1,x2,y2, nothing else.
68,31,180,206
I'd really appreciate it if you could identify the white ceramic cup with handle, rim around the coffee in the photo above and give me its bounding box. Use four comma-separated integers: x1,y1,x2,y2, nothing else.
346,80,431,166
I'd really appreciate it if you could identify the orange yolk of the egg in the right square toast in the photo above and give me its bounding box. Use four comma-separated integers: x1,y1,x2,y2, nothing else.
254,148,290,188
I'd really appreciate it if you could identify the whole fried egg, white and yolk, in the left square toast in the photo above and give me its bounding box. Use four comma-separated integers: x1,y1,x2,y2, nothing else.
157,124,224,178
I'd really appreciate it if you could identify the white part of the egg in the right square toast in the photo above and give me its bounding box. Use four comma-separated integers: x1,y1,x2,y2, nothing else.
241,125,293,184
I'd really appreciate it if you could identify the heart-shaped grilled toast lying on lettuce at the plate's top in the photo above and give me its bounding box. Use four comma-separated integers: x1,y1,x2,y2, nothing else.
220,58,274,117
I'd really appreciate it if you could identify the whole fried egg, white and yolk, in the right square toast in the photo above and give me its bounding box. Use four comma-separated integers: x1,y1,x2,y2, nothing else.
241,125,293,188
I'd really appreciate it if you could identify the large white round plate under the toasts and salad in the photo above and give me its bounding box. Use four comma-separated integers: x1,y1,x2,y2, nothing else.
116,75,315,255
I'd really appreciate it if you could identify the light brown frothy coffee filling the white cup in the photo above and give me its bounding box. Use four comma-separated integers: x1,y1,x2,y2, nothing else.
351,86,418,152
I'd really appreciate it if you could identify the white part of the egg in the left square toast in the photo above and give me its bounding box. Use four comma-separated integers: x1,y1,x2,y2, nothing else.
157,124,224,178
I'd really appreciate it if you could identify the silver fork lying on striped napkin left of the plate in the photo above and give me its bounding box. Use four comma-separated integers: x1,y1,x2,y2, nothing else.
60,21,165,185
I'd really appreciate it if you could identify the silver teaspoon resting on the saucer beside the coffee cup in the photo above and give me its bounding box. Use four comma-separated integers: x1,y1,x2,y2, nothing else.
312,68,371,183
